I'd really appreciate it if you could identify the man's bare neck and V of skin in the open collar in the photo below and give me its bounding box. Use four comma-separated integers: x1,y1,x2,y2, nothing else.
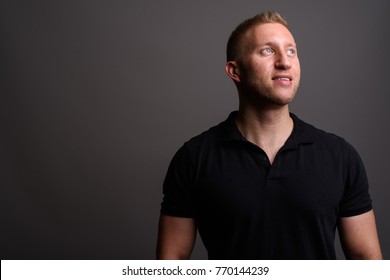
236,105,294,163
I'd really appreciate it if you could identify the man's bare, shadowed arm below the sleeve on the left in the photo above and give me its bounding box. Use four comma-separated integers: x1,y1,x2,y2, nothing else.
156,215,197,259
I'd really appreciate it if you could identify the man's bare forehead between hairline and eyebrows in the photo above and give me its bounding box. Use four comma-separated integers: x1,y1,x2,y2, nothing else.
243,23,295,45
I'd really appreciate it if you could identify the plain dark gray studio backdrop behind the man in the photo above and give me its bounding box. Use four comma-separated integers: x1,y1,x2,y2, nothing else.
0,0,390,259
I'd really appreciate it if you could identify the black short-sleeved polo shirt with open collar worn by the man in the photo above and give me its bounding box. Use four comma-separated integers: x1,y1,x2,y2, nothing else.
161,112,372,259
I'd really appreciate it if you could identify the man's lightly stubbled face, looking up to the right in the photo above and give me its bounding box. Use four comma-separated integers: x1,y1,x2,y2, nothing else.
237,23,300,106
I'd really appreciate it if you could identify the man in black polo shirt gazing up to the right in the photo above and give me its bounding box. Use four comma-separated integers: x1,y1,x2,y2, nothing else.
157,12,382,259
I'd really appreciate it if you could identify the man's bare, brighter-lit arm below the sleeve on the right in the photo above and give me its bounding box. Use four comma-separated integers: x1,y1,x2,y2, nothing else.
338,210,382,259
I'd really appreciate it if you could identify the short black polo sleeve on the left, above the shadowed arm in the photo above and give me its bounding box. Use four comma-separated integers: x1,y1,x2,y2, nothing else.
161,145,194,218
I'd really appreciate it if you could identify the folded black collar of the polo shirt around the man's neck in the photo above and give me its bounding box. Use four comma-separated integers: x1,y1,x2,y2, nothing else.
222,111,314,147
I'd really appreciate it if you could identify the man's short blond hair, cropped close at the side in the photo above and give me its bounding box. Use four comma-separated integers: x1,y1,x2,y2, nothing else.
226,11,288,61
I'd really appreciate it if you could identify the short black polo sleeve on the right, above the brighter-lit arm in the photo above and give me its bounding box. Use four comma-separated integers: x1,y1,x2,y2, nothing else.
340,142,372,217
